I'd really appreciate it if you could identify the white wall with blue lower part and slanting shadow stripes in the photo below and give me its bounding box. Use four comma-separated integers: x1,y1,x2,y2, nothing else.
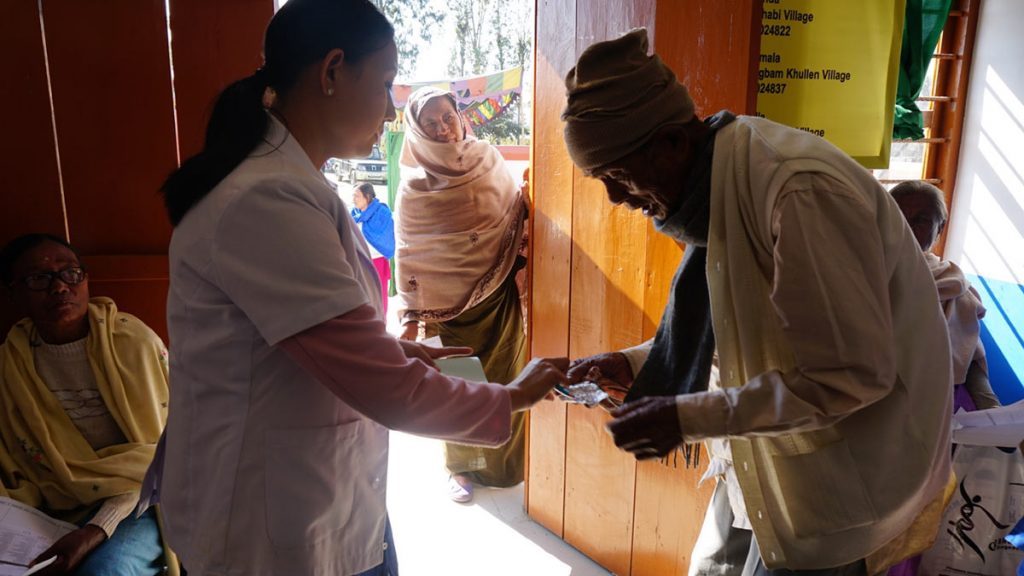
945,0,1024,401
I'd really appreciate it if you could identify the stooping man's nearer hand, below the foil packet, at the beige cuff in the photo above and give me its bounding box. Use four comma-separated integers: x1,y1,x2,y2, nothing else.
607,396,683,460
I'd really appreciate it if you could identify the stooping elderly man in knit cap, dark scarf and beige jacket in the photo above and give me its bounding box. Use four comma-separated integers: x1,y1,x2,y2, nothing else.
562,30,951,575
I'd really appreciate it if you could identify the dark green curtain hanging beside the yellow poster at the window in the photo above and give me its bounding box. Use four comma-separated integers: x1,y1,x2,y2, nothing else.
893,0,952,139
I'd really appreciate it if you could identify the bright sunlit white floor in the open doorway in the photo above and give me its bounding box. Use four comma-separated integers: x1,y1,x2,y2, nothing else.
388,433,609,576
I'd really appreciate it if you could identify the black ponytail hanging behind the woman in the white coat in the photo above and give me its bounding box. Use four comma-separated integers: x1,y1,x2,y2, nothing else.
160,70,269,227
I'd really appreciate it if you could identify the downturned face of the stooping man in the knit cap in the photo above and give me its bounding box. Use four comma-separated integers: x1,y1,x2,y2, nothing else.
590,130,688,220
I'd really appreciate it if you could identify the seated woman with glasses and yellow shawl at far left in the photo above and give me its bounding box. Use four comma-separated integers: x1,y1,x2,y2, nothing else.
0,234,177,575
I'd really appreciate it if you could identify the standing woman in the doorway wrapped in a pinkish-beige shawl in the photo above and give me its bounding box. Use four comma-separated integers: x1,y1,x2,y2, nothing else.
397,87,526,502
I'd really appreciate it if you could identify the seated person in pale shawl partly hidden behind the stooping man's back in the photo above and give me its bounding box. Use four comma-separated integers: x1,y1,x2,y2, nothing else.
890,181,999,410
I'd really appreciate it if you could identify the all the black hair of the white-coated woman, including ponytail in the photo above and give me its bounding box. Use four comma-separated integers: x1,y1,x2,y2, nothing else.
161,0,394,227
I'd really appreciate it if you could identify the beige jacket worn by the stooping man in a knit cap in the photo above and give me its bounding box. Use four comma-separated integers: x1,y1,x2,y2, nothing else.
655,117,952,569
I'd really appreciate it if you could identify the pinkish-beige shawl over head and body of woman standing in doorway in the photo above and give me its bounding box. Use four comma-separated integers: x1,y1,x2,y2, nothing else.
395,87,524,322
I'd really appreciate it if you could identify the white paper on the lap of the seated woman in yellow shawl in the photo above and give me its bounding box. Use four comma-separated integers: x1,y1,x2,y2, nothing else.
0,497,77,565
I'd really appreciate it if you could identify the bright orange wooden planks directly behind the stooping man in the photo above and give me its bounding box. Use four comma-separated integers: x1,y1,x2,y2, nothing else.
527,0,761,576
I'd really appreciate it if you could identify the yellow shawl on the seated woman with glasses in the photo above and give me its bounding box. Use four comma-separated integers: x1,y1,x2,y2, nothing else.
0,298,168,510
